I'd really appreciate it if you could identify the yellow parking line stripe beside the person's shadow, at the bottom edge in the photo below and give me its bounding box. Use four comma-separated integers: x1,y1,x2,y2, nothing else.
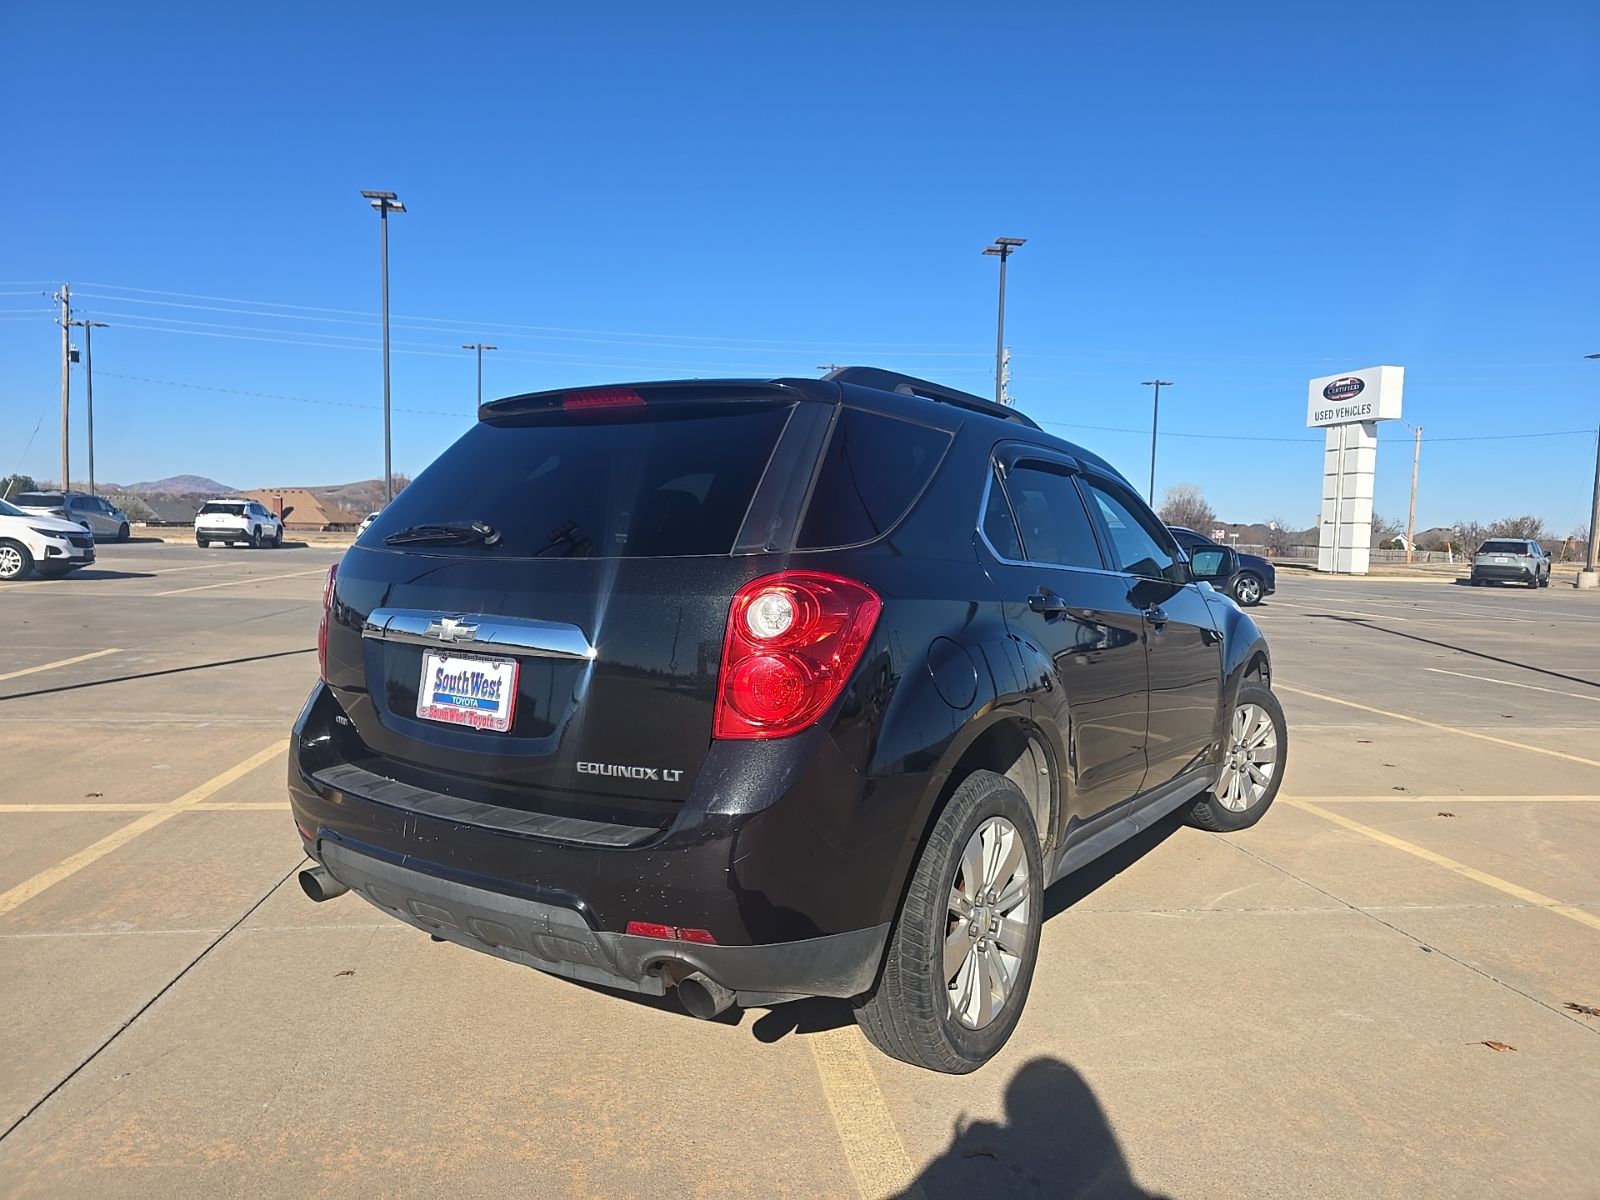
806,1026,923,1200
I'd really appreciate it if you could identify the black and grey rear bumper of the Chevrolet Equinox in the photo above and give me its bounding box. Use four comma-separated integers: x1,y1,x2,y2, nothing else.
288,685,926,1003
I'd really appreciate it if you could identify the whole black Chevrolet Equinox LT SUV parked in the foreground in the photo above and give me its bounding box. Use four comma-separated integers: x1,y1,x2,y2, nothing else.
290,368,1286,1072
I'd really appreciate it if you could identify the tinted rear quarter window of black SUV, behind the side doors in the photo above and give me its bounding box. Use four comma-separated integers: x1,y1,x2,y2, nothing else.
798,408,950,549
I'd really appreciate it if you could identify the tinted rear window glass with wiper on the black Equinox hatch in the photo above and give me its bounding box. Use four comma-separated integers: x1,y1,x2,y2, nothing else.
376,402,792,558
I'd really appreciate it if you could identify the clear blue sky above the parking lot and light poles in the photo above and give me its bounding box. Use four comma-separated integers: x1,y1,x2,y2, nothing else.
0,0,1600,533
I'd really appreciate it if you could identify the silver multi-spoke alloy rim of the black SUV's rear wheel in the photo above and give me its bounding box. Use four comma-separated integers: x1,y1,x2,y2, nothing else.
942,816,1032,1029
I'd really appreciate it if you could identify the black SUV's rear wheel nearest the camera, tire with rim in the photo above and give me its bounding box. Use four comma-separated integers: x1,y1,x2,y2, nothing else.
856,771,1045,1075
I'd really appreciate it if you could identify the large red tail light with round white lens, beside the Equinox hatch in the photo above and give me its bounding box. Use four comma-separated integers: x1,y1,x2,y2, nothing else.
714,571,883,738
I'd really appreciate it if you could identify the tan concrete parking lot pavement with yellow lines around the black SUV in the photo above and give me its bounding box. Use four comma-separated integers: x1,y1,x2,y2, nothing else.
0,556,1600,1197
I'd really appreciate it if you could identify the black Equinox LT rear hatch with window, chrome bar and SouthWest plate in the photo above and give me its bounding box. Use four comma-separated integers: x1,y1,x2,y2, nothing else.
326,384,832,827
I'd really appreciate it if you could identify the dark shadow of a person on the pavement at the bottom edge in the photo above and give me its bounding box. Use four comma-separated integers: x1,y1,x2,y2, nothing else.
899,1056,1162,1200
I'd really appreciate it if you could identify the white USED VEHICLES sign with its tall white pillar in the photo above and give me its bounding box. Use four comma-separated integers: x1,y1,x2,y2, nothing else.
1306,366,1405,574
